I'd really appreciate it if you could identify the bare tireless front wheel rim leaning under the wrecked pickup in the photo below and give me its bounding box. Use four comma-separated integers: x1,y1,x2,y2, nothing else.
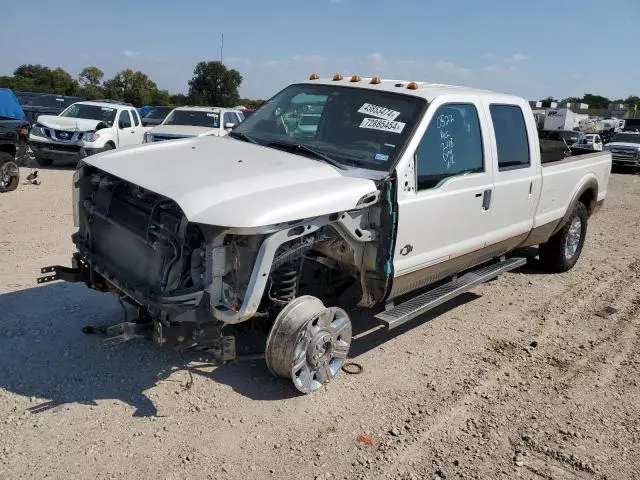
265,296,351,393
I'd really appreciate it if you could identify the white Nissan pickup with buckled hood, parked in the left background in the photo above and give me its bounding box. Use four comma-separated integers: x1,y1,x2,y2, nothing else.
29,101,144,166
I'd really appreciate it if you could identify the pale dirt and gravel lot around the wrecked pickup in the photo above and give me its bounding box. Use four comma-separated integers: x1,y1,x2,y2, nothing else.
0,165,640,480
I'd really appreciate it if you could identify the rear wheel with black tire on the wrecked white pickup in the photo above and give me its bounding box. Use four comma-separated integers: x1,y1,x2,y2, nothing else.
539,202,589,272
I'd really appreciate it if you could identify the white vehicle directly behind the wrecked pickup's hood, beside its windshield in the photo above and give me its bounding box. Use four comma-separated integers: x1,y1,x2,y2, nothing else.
144,107,244,143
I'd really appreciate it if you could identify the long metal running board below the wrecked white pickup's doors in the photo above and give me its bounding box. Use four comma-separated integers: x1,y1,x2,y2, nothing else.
375,257,527,330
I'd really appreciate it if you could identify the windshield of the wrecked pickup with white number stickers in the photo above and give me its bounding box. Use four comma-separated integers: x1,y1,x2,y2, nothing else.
232,84,426,170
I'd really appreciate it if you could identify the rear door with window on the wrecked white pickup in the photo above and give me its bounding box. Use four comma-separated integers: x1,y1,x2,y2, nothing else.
486,103,542,244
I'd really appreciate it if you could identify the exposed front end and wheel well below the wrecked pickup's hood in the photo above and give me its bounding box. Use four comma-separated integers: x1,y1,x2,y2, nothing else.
67,165,392,352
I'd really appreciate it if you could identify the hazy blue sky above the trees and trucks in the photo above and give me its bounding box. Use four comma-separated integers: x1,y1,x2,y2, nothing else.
0,0,640,100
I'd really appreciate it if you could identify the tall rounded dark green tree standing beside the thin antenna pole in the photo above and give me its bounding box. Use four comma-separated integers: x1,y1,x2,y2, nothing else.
189,62,242,107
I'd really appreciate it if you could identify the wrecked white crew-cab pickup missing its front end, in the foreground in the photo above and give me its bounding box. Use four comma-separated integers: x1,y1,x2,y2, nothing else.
39,75,611,393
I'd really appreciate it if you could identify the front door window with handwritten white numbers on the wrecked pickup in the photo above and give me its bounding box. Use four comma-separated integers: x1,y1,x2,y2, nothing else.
416,103,484,190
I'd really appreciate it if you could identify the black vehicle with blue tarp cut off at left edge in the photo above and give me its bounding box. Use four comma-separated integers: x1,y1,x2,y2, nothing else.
0,88,29,193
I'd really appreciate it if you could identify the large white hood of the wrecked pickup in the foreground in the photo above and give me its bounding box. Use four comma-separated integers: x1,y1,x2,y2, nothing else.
84,136,376,228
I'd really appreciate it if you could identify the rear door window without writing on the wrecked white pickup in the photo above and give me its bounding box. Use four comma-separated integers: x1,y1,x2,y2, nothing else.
489,105,531,171
